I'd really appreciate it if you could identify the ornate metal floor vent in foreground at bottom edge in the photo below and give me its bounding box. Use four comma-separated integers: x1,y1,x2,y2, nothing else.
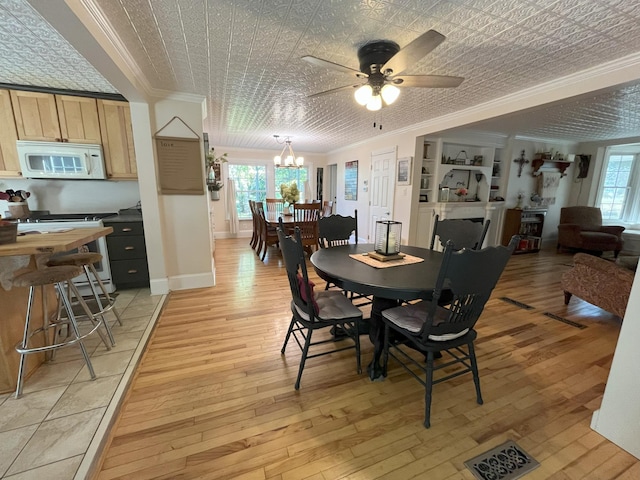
464,440,540,480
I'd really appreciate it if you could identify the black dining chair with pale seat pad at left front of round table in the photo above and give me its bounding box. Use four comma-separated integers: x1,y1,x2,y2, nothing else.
278,221,362,390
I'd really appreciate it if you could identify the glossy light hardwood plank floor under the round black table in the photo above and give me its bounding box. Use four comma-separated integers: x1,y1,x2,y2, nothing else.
95,239,640,480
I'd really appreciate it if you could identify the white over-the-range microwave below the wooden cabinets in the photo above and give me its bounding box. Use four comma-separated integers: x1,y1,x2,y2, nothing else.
16,140,107,180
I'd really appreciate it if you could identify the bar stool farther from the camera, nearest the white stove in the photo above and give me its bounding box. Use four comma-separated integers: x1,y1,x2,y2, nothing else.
47,252,122,338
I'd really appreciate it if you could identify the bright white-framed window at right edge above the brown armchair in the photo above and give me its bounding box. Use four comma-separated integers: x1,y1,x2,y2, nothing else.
596,145,640,223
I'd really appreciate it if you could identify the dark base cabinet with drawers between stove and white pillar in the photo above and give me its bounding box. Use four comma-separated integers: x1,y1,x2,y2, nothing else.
103,214,149,290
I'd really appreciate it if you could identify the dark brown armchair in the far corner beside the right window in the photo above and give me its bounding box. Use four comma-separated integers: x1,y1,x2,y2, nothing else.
558,207,624,257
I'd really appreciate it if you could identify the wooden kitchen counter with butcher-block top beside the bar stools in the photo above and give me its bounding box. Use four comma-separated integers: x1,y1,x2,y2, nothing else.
0,227,113,393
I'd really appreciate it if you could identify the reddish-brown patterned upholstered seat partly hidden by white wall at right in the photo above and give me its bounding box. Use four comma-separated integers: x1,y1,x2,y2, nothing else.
560,253,638,318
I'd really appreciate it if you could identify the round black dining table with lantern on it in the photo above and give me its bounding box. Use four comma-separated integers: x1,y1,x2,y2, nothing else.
311,244,443,380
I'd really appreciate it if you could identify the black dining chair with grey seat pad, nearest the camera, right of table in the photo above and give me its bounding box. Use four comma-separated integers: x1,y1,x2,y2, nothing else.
382,236,520,428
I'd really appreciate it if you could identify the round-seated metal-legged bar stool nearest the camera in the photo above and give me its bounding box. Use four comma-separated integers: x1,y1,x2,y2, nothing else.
13,265,101,398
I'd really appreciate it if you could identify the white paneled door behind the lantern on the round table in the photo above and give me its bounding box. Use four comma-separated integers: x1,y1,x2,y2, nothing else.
368,147,396,243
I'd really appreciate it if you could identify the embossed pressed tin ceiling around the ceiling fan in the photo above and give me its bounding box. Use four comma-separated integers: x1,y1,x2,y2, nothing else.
0,0,640,152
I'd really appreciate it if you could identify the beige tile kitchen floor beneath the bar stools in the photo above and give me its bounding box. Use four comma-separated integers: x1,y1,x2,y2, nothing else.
0,289,165,480
